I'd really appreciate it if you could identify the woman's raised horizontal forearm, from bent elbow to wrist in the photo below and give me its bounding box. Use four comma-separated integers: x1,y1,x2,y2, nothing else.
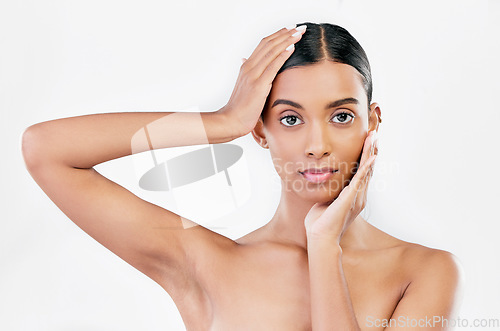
23,112,238,168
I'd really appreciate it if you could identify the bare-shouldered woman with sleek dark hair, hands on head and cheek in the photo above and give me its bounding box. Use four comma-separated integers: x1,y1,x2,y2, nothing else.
23,22,462,330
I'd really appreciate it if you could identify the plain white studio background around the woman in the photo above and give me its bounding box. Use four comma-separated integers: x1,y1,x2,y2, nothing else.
0,0,500,331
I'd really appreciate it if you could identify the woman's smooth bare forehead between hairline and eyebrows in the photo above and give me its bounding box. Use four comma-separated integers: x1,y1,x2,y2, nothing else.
270,61,368,104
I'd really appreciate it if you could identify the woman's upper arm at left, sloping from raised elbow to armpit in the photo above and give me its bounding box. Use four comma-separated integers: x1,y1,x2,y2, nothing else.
23,153,227,292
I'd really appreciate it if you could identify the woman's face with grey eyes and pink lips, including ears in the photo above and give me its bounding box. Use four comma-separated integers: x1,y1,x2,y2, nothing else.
253,61,380,202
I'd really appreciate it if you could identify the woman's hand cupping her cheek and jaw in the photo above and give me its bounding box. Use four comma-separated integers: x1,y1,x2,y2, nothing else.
304,130,378,244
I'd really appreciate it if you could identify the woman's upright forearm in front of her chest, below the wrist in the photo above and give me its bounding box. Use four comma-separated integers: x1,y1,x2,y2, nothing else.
307,238,360,331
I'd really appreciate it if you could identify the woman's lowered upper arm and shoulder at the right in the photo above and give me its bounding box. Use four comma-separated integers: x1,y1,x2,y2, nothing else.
385,249,464,330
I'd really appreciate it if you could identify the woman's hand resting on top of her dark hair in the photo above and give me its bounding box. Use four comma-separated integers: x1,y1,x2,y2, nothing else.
218,25,306,136
